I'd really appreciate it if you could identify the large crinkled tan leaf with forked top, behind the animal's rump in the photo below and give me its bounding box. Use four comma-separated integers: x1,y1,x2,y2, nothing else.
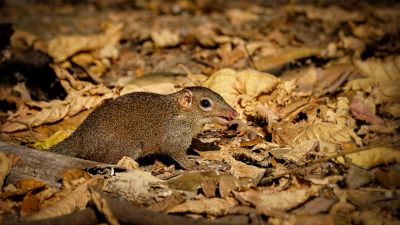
2,67,117,132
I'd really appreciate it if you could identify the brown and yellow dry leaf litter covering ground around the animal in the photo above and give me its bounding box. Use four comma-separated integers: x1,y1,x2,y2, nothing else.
0,0,400,224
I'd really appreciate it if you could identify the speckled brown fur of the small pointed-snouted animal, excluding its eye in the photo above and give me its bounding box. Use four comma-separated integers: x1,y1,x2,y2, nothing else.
51,87,237,169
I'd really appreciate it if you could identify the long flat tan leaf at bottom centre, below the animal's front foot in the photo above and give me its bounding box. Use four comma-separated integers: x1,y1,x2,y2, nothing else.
168,198,237,216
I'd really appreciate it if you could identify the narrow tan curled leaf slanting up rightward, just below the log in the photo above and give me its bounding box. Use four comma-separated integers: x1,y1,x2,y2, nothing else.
27,178,100,220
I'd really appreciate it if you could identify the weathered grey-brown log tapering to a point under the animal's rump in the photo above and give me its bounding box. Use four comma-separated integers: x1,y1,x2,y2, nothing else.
0,141,105,188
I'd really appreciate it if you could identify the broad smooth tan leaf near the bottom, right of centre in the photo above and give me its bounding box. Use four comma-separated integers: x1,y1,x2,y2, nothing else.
235,188,317,215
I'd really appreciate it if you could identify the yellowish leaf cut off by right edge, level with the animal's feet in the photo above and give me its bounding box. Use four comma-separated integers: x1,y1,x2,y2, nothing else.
337,147,400,169
